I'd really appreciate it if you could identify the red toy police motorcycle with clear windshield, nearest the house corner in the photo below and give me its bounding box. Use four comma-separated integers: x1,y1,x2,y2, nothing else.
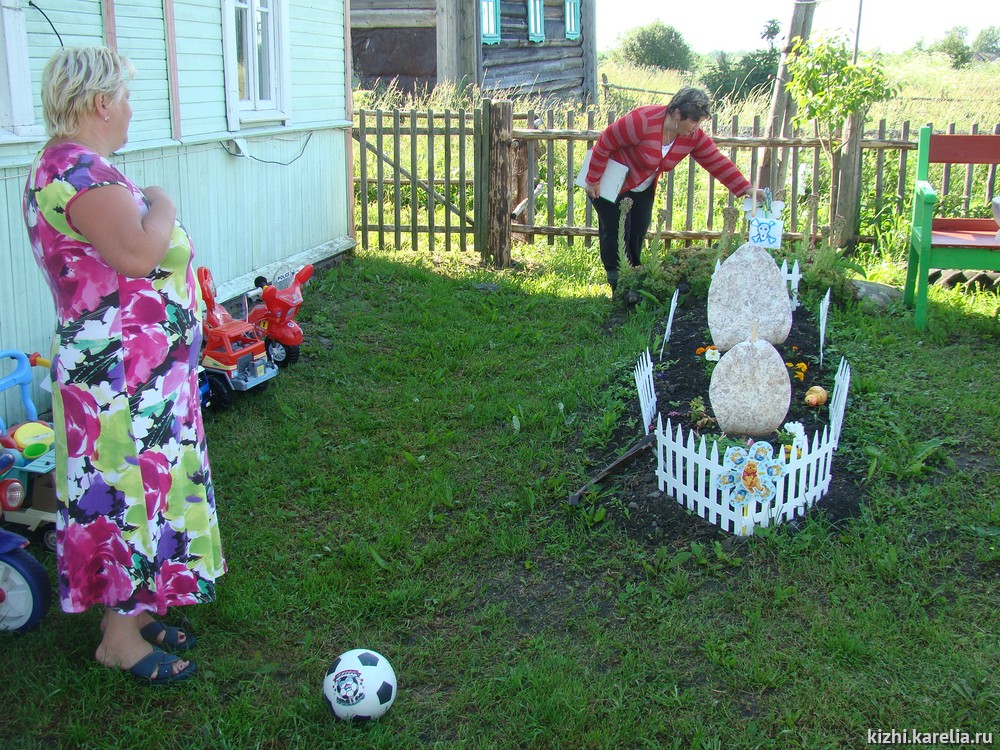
247,263,313,367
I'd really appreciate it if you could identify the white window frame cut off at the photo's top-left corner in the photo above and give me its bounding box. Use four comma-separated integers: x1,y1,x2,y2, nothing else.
0,0,44,140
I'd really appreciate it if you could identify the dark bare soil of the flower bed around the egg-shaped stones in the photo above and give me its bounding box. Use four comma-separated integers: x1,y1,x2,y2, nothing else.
582,299,864,547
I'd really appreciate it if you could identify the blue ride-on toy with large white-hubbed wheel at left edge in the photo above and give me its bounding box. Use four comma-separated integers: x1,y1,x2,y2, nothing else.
0,453,52,632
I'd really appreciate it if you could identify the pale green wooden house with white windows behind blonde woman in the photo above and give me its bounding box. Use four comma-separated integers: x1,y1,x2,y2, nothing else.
0,0,354,424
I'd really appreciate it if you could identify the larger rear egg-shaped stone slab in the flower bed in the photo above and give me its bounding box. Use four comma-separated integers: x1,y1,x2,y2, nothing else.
708,244,792,352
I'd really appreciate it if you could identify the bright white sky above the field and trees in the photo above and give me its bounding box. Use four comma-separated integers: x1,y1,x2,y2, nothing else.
596,0,1000,54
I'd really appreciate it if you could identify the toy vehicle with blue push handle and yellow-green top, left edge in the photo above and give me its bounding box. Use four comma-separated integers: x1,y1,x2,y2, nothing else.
0,350,56,552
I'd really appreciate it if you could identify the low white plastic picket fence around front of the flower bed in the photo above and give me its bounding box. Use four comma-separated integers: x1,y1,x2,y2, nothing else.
656,359,851,536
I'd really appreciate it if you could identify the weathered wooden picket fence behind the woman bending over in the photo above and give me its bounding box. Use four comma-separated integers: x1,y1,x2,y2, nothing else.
353,100,1000,266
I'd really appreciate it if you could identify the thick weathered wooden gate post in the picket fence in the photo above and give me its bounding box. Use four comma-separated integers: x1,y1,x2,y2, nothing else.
483,101,514,268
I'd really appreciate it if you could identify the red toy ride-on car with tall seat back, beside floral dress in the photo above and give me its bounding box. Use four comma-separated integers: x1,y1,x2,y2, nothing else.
197,266,278,408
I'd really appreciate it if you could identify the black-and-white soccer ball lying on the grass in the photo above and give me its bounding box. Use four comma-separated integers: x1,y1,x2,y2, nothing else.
323,648,396,721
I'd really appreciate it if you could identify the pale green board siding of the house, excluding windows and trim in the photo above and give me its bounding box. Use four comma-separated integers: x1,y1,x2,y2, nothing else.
0,0,353,424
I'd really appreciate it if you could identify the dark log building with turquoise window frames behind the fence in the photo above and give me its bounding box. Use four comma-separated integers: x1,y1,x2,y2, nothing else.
350,0,597,102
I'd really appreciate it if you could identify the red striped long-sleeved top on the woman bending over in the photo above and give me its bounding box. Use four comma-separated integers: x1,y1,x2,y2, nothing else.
587,105,751,200
